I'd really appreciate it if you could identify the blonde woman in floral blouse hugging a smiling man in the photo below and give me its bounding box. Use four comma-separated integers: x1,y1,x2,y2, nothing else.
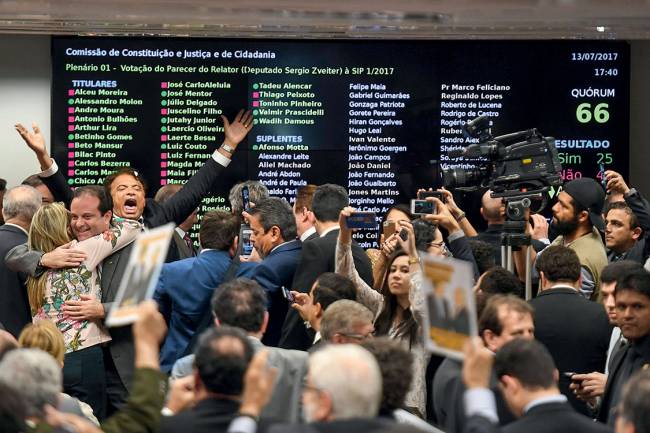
27,203,142,419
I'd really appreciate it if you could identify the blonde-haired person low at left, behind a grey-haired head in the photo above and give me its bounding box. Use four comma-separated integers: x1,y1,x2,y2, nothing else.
18,320,99,426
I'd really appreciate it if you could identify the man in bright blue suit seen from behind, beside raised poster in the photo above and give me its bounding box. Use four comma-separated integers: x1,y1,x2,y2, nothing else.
153,211,239,373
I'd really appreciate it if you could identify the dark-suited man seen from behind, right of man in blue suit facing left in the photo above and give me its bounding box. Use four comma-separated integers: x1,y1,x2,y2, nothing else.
279,184,373,350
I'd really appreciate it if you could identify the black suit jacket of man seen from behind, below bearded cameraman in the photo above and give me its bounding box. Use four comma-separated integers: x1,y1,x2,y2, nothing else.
530,287,612,415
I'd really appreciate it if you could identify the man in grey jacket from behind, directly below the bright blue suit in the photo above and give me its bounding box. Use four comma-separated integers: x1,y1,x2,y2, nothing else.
170,278,308,422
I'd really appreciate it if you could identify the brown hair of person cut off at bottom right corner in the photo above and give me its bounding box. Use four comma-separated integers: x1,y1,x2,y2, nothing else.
619,370,650,433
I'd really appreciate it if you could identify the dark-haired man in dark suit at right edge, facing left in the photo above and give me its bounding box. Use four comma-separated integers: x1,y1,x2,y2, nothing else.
598,270,650,426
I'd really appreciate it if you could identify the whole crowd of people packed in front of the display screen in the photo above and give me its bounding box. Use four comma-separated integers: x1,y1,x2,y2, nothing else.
0,111,650,433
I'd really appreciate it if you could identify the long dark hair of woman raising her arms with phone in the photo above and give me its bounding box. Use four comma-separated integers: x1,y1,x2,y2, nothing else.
375,251,419,346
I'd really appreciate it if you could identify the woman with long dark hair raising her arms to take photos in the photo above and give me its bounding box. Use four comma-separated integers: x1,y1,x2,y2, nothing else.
336,207,429,418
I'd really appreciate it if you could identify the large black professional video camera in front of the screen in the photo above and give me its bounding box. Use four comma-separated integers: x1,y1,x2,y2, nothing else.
443,116,562,208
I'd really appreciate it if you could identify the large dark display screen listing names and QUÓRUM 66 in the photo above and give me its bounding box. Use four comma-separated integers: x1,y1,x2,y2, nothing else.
52,38,629,247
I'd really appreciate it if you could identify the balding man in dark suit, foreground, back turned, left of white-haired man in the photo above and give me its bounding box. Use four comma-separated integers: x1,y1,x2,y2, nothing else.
159,326,253,433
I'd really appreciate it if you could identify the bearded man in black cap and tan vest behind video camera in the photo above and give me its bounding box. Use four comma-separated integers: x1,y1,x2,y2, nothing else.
515,177,607,300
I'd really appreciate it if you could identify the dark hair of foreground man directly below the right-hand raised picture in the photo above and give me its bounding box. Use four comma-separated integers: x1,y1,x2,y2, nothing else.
494,338,556,390
